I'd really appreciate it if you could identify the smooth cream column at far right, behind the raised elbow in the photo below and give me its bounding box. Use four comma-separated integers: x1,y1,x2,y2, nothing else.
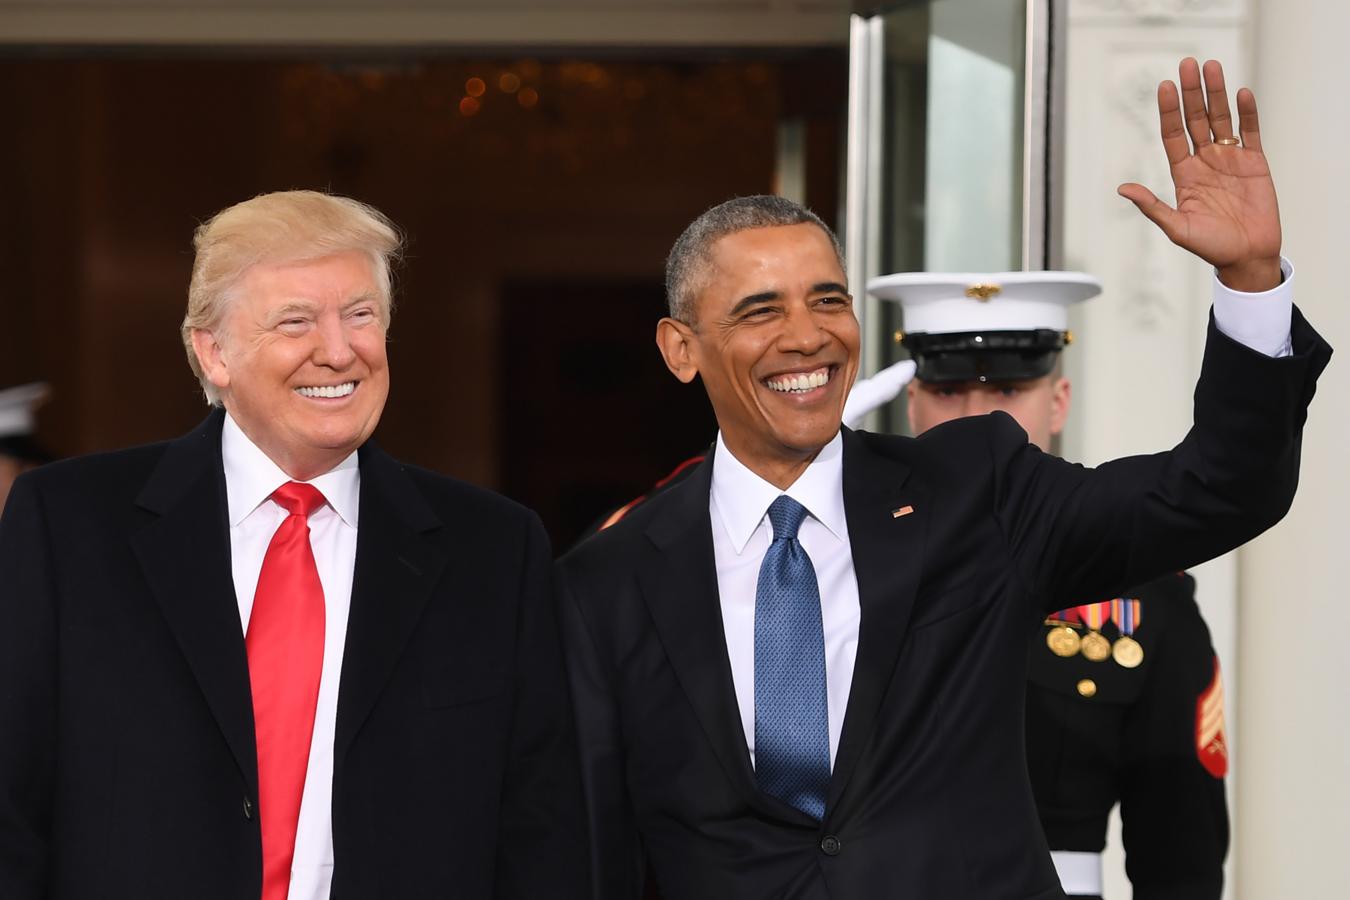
1234,0,1350,900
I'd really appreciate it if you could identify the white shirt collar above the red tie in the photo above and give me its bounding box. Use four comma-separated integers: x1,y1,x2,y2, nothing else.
220,413,360,528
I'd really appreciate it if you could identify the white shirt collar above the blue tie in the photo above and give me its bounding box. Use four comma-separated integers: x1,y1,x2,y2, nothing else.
713,432,848,556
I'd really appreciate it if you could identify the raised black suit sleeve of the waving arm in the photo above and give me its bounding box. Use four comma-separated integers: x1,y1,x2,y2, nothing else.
991,310,1331,611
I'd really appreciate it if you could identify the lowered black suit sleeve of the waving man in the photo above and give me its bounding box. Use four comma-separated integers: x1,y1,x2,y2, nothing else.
556,565,644,900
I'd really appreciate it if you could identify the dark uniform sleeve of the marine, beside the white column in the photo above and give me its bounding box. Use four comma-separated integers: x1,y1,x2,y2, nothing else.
1121,578,1229,900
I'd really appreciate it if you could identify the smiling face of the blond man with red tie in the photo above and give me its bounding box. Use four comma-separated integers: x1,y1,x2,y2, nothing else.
193,251,389,480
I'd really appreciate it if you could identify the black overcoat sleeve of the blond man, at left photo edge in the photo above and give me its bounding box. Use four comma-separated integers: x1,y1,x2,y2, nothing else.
0,478,57,900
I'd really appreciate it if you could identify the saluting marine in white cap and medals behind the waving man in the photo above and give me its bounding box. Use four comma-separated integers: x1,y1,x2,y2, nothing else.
871,273,1229,900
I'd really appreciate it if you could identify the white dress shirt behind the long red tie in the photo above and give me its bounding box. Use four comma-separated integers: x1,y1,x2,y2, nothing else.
220,414,360,900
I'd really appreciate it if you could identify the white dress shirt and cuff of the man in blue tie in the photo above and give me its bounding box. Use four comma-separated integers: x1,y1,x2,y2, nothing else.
707,259,1293,768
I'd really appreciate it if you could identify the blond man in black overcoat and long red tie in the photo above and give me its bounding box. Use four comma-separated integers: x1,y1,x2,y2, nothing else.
0,192,587,900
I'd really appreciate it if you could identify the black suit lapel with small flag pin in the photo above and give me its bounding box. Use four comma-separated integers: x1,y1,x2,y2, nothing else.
828,429,929,810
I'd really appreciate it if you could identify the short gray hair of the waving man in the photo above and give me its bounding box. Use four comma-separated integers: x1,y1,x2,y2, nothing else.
666,194,844,325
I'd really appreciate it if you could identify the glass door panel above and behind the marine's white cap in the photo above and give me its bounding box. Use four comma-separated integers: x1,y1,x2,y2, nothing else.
844,0,1048,430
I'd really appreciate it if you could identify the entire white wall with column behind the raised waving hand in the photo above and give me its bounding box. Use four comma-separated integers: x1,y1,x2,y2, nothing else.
1065,0,1350,900
